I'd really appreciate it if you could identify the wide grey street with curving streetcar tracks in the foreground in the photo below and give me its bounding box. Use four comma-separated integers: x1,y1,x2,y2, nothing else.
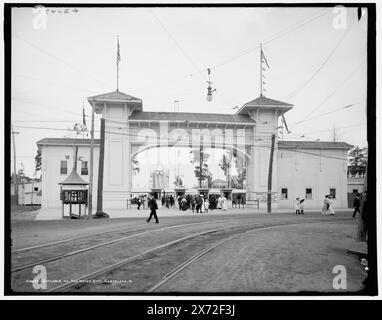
12,210,364,293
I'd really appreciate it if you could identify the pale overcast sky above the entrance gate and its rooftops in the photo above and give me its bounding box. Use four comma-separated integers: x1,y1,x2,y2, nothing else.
11,7,367,185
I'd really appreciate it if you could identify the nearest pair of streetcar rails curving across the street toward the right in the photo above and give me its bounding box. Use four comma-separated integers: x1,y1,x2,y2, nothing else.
46,218,352,292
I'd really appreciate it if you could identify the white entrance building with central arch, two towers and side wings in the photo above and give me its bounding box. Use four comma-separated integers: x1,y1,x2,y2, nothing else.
37,91,352,212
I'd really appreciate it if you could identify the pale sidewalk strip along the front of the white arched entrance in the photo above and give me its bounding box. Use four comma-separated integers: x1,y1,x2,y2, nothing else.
35,207,352,220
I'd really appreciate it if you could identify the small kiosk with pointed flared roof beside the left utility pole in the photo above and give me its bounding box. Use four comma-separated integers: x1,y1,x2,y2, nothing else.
59,169,89,219
